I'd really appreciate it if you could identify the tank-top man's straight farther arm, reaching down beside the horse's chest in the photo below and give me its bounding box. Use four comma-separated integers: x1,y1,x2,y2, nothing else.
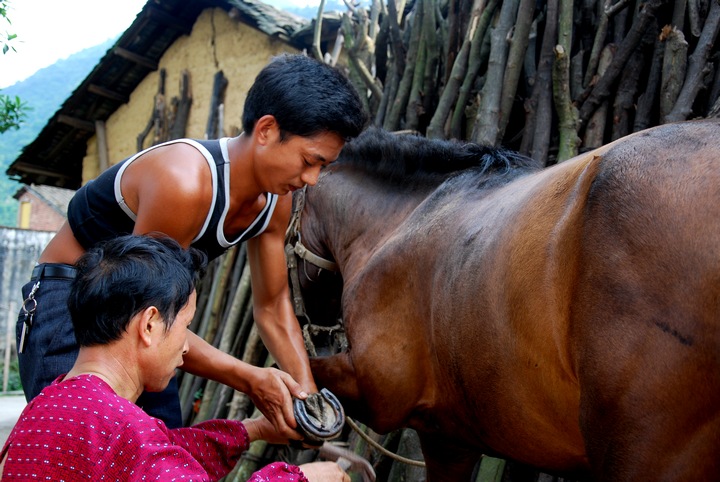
248,195,317,393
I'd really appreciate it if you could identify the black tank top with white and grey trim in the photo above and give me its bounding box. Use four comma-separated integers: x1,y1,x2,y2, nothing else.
68,138,278,259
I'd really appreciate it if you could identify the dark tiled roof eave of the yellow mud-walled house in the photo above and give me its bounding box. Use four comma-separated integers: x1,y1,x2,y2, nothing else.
6,0,318,189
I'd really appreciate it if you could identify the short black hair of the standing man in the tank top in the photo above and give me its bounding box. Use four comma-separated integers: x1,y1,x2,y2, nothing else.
243,54,367,141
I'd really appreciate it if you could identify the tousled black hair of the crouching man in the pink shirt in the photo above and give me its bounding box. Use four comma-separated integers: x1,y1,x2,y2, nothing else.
68,234,207,346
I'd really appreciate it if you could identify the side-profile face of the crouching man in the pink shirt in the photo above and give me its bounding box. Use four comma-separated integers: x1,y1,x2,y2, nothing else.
145,291,197,391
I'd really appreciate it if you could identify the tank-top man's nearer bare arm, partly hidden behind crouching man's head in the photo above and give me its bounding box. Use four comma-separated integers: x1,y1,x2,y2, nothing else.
122,144,306,439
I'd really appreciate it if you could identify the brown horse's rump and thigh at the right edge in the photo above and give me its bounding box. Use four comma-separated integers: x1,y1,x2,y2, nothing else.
571,121,720,480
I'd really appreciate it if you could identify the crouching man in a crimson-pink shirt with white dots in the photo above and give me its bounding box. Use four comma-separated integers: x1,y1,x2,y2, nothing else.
0,235,350,482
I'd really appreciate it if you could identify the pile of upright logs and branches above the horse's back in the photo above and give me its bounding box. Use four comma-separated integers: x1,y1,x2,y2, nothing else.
344,0,720,165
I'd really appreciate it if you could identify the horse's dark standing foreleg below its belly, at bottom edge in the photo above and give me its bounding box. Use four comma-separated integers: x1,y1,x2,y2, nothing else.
418,433,480,482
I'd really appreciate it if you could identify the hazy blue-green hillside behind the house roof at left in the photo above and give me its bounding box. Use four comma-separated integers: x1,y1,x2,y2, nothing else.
0,39,115,226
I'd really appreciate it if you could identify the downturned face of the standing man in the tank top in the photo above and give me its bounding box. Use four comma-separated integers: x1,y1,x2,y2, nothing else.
260,132,345,195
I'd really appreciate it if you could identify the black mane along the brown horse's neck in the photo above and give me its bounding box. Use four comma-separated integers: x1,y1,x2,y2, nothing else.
338,127,542,183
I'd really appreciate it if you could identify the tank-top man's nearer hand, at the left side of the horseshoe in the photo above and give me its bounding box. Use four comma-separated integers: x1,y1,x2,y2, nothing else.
247,368,308,443
